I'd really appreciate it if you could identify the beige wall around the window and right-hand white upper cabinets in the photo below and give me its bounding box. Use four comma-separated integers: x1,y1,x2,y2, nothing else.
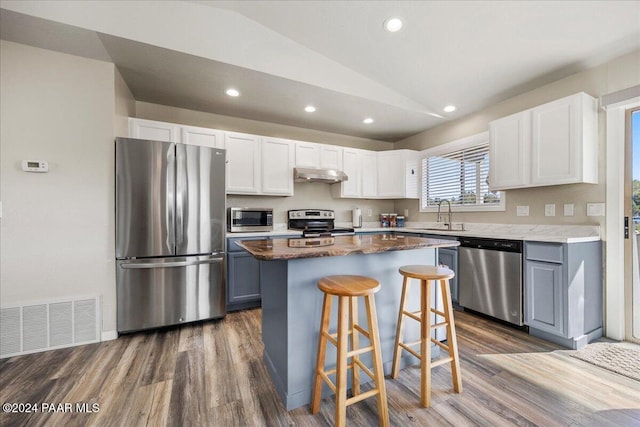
395,51,640,231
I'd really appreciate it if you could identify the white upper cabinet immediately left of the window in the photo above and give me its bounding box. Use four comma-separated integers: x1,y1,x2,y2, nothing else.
378,150,418,199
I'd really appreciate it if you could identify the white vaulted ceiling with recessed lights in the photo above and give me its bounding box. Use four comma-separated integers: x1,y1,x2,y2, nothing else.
0,0,640,141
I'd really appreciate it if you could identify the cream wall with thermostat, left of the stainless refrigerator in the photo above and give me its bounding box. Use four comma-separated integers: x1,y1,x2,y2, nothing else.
0,41,116,338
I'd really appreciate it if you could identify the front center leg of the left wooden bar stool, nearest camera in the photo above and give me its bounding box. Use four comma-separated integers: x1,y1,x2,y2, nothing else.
335,297,349,427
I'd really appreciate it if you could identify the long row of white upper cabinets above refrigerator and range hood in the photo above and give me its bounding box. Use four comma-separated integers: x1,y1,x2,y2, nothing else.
129,118,418,199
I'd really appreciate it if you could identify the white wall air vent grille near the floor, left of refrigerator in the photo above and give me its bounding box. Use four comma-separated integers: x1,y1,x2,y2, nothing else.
0,297,100,358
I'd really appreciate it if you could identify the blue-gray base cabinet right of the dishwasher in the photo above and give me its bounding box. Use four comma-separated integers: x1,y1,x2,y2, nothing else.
524,241,602,349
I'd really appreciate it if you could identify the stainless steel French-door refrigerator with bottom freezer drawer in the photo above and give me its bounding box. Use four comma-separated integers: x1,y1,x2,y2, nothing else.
115,138,226,332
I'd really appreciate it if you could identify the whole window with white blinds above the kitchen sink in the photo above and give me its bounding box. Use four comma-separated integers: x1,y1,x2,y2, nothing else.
420,132,505,212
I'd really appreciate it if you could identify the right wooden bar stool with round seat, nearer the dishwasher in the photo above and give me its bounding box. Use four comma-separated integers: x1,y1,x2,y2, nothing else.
391,265,462,408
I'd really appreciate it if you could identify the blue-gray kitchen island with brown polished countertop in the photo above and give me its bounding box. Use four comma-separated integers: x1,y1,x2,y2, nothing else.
239,233,458,410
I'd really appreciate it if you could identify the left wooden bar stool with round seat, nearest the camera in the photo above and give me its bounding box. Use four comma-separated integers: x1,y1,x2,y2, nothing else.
311,275,389,426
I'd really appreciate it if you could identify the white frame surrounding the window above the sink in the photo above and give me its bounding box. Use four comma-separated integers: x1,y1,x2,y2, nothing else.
419,132,507,212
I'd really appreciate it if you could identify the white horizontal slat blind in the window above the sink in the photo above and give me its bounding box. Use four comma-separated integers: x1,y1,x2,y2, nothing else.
421,143,500,209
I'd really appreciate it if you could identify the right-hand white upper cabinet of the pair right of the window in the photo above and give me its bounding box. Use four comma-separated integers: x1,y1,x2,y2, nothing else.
531,93,598,186
